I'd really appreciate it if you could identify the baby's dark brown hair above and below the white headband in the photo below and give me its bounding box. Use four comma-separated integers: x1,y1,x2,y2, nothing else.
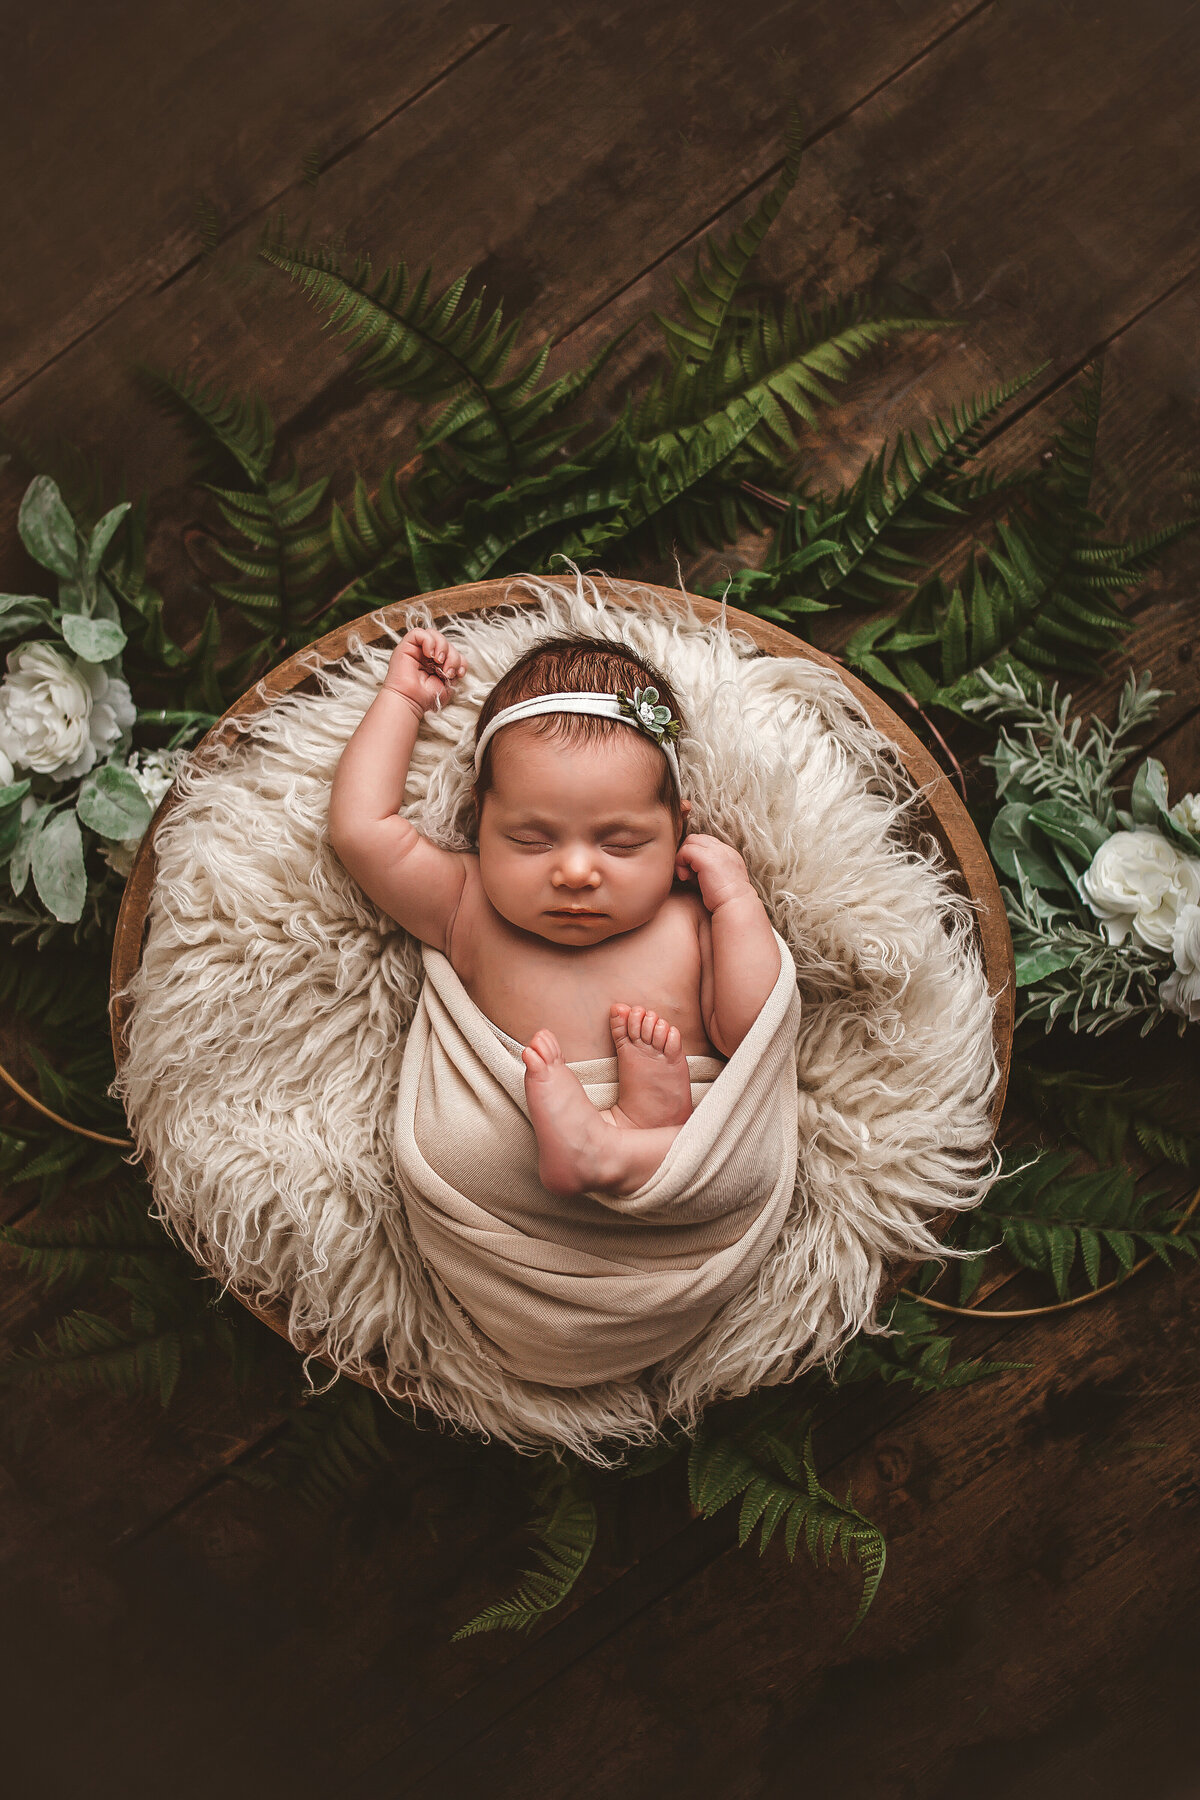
475,634,684,833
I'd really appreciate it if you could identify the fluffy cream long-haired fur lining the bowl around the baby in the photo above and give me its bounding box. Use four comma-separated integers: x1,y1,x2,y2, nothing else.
119,576,997,1462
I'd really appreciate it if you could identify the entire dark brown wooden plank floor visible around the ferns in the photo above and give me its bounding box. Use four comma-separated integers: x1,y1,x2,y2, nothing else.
0,0,1200,1800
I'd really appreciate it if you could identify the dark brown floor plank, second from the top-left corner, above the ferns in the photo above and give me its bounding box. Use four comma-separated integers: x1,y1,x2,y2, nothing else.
0,0,975,488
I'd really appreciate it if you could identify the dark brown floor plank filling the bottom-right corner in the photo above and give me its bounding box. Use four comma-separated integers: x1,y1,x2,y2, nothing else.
379,1276,1200,1800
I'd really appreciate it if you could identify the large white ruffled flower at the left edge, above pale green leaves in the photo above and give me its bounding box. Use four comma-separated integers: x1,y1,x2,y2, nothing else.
0,644,137,781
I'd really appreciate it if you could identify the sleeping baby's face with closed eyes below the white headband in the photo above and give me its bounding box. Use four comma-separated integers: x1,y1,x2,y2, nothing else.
479,725,676,945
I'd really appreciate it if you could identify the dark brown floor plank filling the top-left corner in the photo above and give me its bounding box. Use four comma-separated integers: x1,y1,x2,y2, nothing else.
0,0,497,394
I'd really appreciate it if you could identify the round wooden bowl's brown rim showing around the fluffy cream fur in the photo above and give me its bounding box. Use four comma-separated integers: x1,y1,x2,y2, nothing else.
110,578,1016,1361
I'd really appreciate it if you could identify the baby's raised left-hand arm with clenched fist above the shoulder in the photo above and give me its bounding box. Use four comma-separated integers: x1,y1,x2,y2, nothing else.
329,630,466,954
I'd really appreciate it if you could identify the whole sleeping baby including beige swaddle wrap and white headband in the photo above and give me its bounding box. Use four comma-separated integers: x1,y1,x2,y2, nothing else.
329,630,799,1386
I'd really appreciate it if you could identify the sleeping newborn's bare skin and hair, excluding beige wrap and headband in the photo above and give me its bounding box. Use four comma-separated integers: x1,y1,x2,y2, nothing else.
329,630,779,1195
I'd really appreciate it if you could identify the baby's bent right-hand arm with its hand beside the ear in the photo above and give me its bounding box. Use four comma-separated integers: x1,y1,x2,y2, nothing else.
675,832,779,1057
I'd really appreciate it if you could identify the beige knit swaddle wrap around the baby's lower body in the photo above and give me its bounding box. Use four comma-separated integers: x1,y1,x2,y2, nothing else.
394,934,801,1388
